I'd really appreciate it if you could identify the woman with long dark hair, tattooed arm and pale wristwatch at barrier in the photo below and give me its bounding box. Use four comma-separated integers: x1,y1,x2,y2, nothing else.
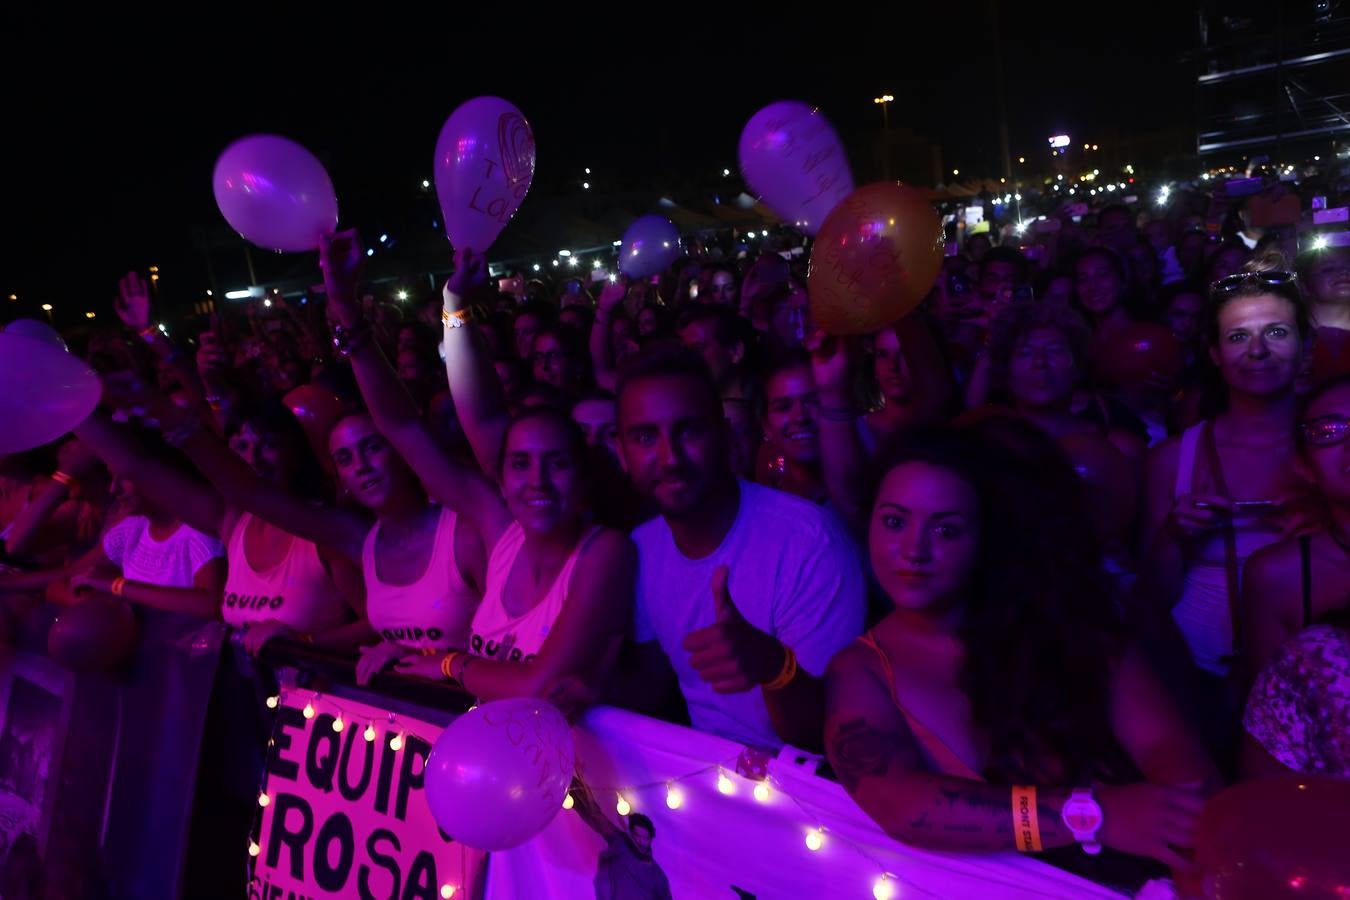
825,429,1218,881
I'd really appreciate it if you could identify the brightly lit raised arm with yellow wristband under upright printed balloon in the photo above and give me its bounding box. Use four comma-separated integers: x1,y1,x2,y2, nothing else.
443,250,509,480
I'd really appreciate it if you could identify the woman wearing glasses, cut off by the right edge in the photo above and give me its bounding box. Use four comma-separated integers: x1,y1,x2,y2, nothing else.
1242,375,1350,671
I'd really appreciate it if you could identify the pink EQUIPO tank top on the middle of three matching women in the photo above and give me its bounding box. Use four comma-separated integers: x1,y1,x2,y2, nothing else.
360,507,481,650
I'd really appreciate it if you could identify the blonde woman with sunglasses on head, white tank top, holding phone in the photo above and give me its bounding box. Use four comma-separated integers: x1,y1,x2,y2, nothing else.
1138,258,1308,766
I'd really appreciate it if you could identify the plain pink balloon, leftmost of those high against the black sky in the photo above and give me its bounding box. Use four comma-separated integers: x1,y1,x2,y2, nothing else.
211,135,338,252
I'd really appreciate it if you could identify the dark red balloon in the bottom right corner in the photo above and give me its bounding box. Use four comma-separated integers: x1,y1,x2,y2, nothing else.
1195,775,1350,900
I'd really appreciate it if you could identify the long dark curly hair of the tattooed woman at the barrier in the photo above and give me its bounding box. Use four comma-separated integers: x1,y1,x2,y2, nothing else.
878,426,1133,784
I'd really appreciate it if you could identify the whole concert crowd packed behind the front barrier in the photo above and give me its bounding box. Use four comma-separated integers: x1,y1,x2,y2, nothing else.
0,175,1350,884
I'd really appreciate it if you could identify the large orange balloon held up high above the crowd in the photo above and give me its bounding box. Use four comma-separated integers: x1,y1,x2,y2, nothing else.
807,181,944,335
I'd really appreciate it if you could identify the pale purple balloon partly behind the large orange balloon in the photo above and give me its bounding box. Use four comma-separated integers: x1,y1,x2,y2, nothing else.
740,100,853,235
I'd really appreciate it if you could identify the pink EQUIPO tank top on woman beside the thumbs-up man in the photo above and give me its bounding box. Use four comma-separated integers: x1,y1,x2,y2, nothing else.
468,522,599,663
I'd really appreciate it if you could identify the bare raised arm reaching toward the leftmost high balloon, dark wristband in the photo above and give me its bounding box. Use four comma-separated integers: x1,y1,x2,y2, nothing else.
319,231,512,546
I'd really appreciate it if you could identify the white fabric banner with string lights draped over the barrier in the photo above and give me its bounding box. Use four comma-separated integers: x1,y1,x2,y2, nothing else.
486,707,1121,900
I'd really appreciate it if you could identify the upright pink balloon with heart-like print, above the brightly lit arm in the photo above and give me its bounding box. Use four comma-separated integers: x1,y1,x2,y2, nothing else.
433,97,535,254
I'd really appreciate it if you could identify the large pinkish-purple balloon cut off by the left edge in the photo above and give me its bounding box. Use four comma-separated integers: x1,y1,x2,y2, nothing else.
0,333,103,453
